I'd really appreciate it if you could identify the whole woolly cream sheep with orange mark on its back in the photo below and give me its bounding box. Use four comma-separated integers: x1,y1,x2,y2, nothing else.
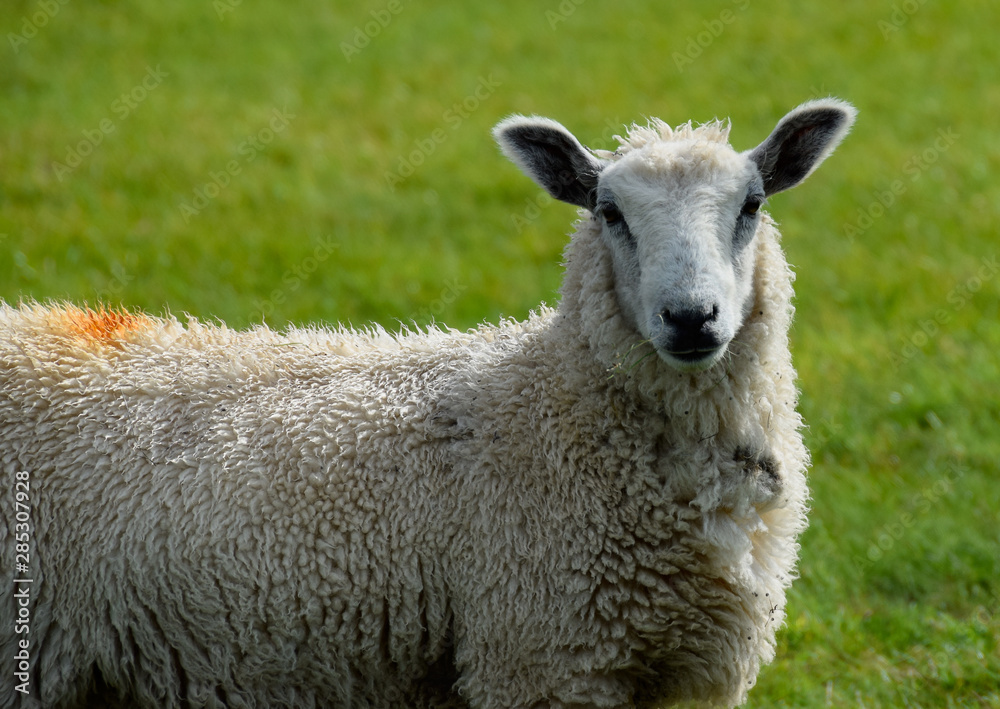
0,99,855,708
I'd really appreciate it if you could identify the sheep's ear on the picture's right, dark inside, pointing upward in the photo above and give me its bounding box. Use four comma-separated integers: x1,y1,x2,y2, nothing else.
750,98,858,195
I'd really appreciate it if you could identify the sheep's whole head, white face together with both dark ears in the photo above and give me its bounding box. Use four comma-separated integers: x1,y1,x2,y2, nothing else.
494,99,856,370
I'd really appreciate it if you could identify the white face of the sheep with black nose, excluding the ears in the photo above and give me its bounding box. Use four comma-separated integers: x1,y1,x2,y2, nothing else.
594,140,764,370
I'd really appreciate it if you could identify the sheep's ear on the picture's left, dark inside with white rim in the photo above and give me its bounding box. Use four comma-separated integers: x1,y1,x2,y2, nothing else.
493,116,603,210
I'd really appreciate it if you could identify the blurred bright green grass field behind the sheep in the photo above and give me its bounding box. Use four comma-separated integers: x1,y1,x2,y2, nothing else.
0,0,1000,708
